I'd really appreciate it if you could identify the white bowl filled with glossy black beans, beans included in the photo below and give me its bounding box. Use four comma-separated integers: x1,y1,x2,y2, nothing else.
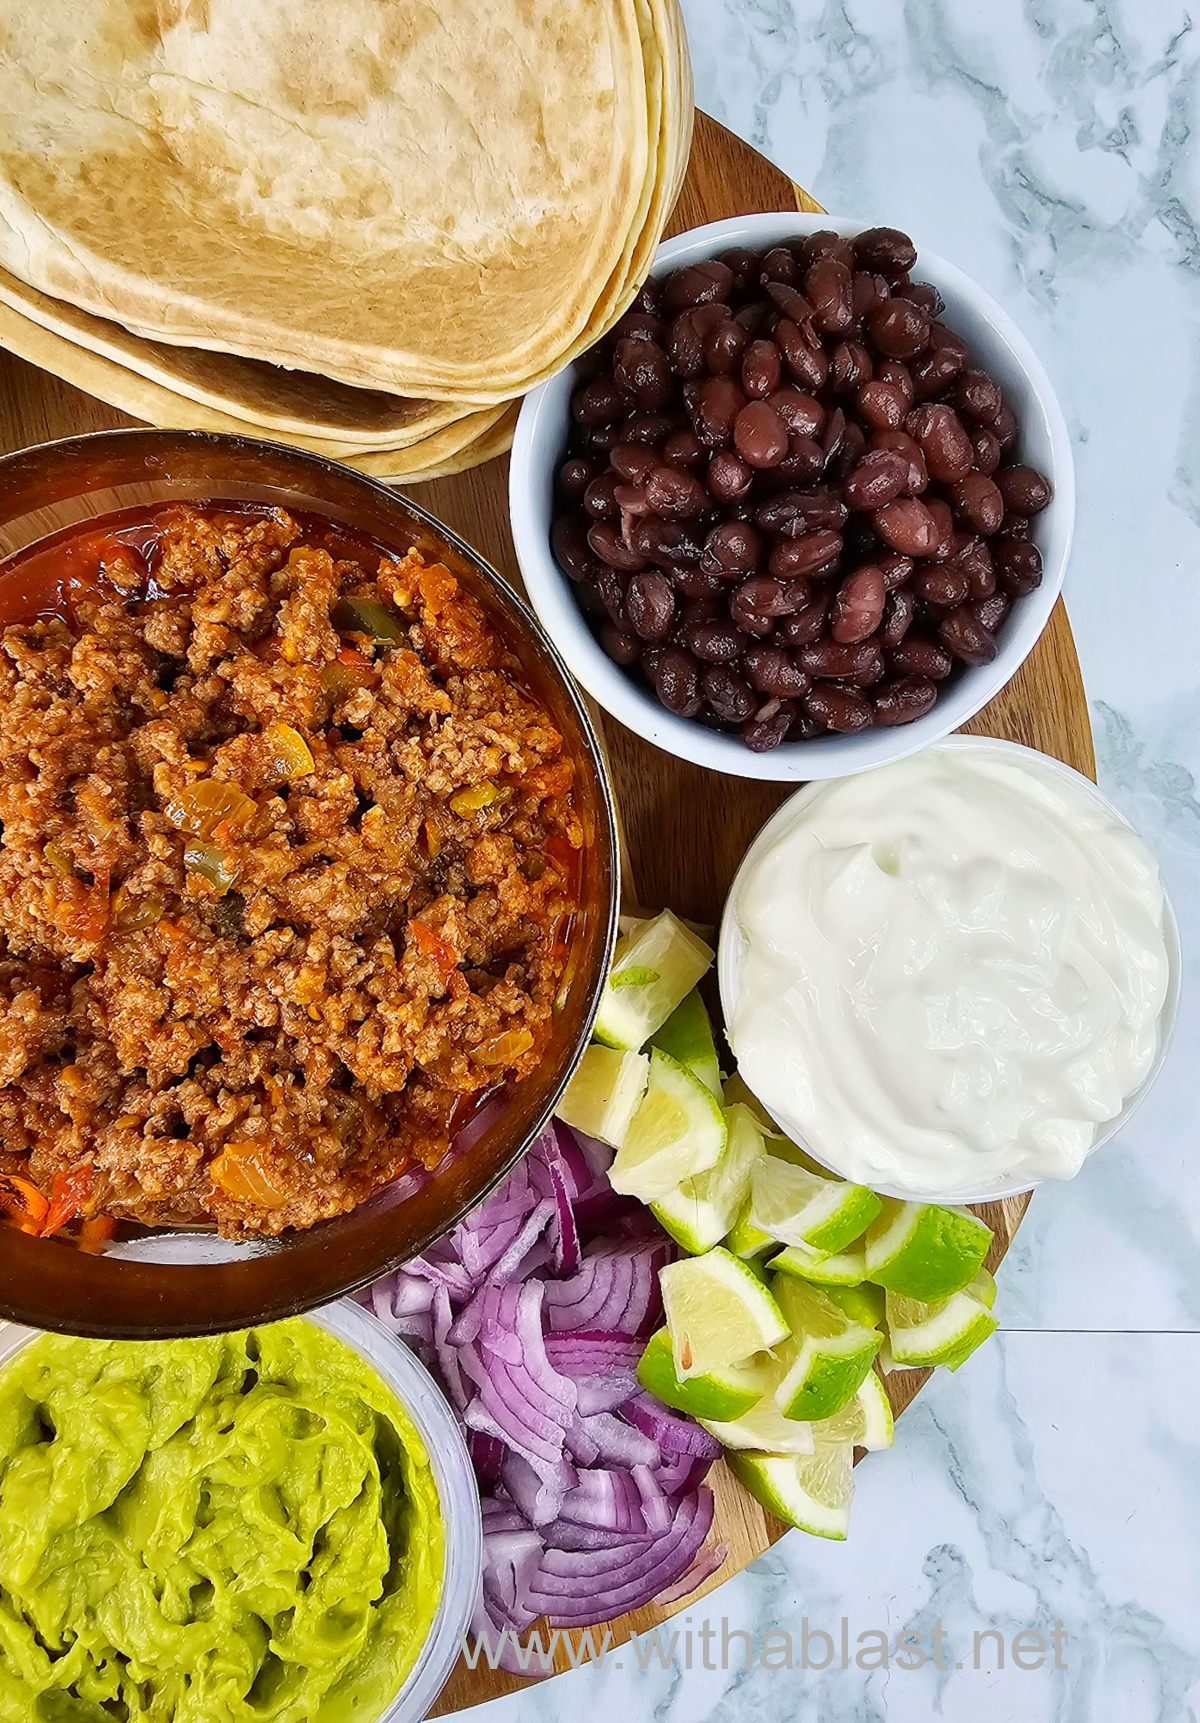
509,214,1074,779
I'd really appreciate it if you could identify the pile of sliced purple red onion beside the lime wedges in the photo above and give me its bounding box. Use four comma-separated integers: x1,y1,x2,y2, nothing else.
362,1122,722,1640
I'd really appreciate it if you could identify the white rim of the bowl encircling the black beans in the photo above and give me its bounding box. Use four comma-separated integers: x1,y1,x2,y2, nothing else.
509,210,1076,782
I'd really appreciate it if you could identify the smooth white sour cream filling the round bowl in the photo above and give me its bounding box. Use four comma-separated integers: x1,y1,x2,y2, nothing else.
721,737,1171,1201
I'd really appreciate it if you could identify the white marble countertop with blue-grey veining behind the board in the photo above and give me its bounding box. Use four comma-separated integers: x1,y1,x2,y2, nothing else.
441,0,1200,1723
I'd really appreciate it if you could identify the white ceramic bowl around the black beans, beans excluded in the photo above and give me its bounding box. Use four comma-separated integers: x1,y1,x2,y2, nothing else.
509,214,1074,781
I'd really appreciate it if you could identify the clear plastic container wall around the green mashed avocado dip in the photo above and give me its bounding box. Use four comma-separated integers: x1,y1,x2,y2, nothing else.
0,1299,483,1723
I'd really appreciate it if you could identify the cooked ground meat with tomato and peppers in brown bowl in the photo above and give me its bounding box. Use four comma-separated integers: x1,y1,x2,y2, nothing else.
0,507,581,1237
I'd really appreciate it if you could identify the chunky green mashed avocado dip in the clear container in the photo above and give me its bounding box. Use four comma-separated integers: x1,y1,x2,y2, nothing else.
0,1318,443,1723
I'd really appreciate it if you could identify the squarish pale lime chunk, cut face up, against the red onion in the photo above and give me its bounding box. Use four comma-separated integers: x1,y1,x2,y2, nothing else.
659,1246,788,1380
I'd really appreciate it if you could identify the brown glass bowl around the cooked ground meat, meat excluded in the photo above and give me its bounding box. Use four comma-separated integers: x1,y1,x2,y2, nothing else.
0,431,619,1340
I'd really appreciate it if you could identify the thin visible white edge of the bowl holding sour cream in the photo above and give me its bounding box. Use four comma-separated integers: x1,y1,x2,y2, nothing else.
717,736,1183,1203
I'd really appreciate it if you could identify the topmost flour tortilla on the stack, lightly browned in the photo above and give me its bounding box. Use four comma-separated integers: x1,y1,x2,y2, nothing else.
0,0,655,405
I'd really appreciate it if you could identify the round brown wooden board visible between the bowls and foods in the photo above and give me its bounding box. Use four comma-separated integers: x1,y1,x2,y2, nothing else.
0,114,1095,1716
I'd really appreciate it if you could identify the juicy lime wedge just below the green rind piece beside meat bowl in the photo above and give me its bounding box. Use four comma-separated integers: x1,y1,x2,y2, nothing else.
609,1049,728,1203
